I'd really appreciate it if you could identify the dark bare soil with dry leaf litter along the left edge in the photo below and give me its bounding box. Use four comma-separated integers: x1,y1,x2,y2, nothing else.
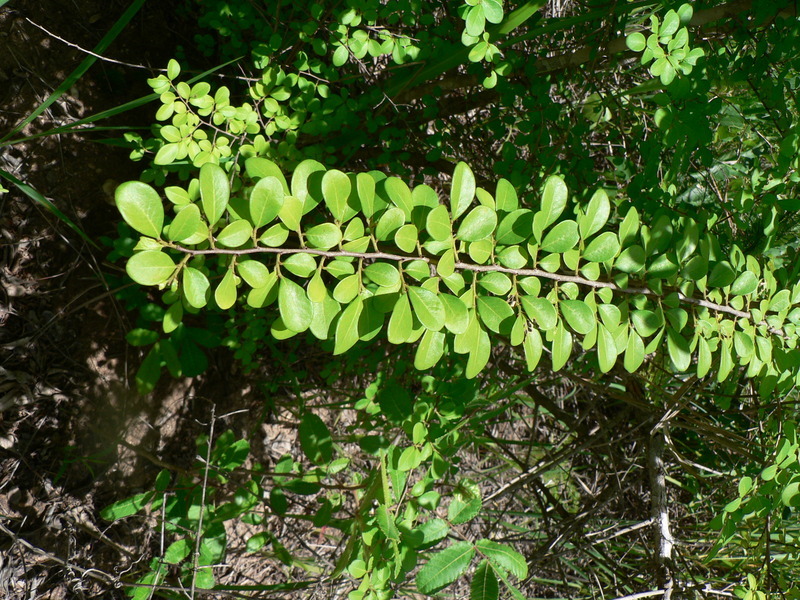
0,0,253,599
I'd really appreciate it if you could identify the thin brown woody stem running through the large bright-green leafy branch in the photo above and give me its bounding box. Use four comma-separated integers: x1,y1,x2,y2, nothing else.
170,245,753,321
